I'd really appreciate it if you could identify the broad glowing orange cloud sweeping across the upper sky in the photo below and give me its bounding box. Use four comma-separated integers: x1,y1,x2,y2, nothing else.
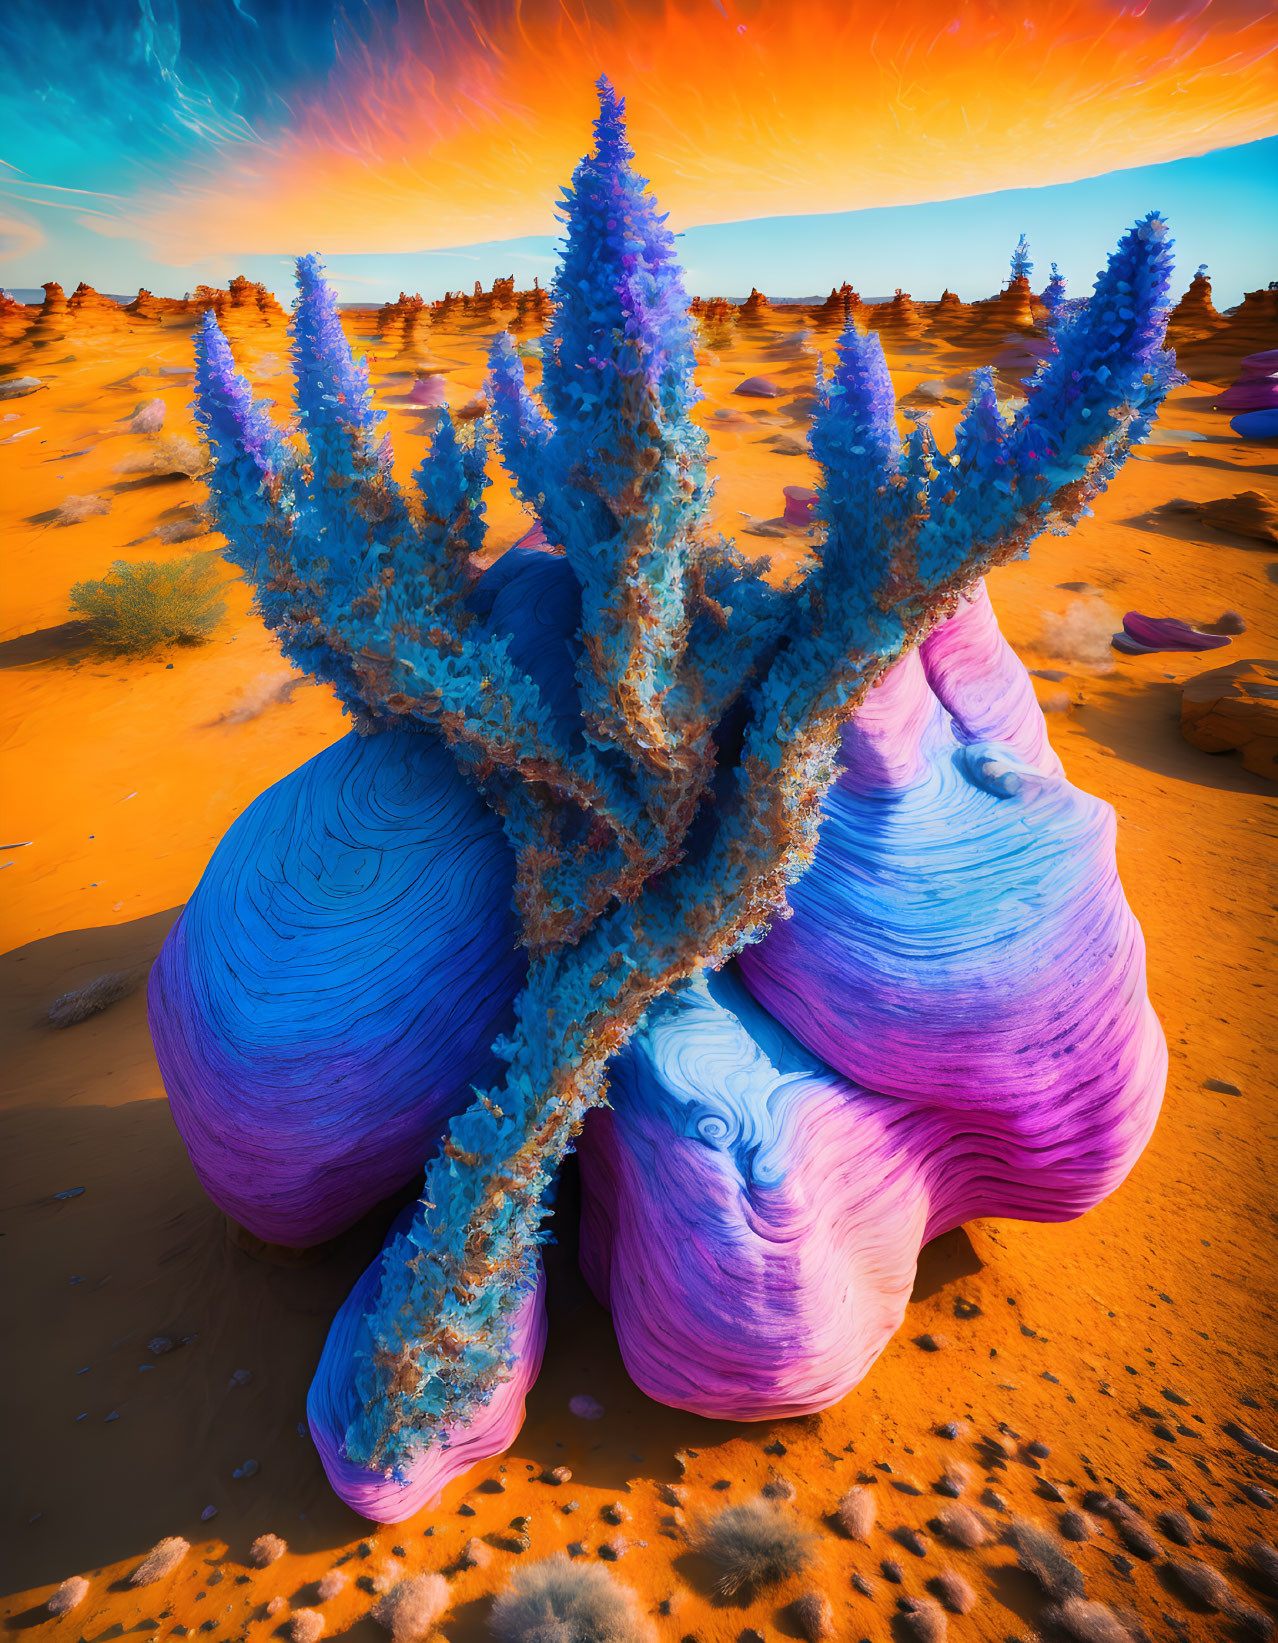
135,0,1278,263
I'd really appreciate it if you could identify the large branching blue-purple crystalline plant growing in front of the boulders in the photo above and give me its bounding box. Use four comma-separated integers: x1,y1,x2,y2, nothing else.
188,82,1173,1472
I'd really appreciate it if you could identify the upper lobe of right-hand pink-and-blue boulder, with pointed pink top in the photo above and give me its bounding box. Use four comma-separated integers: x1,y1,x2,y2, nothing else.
741,578,1163,1130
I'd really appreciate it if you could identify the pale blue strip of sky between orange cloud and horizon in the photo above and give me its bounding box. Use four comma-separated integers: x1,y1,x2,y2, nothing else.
5,138,1278,306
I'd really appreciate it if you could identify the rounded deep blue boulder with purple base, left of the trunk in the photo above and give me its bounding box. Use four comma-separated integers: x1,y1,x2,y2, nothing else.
148,729,524,1247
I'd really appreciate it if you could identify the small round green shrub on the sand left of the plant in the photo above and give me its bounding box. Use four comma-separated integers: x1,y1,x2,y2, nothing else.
71,554,227,656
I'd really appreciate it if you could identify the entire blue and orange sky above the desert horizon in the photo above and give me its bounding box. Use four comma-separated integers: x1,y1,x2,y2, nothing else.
0,0,1278,306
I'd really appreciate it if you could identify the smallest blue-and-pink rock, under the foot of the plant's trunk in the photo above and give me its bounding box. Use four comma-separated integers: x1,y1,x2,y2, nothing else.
306,1242,545,1523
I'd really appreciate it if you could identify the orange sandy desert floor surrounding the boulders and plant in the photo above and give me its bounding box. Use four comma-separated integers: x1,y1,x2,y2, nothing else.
0,299,1278,1643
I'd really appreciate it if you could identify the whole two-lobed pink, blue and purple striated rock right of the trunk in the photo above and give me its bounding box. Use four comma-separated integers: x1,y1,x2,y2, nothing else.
578,588,1166,1420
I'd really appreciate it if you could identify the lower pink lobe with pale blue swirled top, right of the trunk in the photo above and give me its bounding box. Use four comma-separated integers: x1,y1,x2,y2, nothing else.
578,971,1161,1420
